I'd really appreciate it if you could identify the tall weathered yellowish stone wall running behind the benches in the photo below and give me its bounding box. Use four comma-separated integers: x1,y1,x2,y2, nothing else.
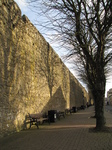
0,0,87,137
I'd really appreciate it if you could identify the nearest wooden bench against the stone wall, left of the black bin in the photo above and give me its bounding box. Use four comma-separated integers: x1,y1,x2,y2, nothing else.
25,113,50,129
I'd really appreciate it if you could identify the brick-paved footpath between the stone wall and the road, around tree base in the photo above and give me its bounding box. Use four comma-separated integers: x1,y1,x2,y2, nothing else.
0,106,112,150
